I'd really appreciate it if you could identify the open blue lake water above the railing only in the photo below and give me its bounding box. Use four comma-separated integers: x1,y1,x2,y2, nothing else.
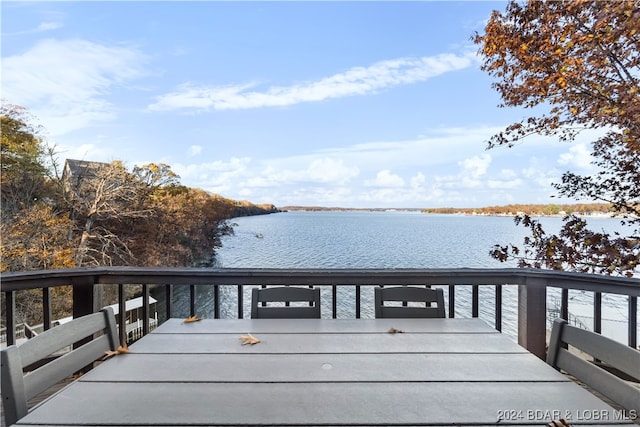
218,212,540,268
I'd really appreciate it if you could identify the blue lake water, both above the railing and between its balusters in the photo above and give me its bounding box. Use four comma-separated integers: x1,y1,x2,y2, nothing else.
166,211,626,342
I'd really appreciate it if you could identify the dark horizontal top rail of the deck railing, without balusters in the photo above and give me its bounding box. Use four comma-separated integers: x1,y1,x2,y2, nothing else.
2,267,640,296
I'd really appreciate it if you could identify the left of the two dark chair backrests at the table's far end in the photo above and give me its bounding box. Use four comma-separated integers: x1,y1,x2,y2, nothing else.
251,286,320,319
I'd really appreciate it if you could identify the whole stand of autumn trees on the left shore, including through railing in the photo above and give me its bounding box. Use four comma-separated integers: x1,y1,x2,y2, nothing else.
0,103,237,323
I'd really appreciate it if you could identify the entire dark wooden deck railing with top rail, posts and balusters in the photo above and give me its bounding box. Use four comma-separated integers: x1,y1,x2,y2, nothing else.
1,267,640,358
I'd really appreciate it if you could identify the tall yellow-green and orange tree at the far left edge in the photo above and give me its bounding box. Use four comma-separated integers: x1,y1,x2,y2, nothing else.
0,103,73,271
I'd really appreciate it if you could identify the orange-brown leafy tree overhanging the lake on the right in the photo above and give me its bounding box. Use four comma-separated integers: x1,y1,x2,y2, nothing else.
473,0,640,275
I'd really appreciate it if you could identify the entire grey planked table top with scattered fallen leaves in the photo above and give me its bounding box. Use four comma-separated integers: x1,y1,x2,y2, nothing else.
19,319,630,426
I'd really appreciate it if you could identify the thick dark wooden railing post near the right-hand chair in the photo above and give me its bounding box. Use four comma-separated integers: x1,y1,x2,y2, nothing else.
518,277,547,360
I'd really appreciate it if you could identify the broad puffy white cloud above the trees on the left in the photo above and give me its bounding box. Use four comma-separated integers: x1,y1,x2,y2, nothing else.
2,38,144,135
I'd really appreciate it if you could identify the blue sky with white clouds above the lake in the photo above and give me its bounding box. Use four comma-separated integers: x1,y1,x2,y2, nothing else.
0,1,598,208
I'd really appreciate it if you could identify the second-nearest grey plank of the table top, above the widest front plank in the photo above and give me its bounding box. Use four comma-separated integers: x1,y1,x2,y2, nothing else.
82,353,570,382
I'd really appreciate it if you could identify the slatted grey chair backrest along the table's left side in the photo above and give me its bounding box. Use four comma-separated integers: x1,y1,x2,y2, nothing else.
0,308,118,425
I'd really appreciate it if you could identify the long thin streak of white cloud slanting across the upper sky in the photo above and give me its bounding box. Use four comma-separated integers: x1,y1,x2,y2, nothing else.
149,54,476,110
